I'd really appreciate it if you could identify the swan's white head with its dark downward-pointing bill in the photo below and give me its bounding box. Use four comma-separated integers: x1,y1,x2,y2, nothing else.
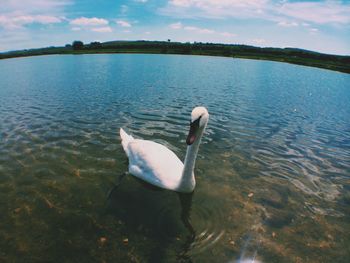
186,107,209,145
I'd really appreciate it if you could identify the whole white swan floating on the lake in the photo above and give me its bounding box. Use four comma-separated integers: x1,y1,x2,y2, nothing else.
120,107,209,193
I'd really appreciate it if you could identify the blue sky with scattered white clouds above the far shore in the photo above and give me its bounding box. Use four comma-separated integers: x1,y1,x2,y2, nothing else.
0,0,350,55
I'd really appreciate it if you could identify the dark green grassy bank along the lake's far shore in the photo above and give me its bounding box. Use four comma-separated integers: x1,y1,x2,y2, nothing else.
0,41,350,73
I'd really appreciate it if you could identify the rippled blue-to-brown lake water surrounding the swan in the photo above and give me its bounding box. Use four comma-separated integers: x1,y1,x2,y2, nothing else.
0,54,350,263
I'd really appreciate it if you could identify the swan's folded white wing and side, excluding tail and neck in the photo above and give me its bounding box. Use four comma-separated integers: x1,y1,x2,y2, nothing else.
128,139,183,190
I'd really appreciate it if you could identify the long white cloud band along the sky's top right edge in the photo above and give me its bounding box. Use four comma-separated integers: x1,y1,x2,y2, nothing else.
159,0,350,25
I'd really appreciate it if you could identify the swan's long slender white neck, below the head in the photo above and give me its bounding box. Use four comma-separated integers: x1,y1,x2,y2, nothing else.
181,128,204,191
